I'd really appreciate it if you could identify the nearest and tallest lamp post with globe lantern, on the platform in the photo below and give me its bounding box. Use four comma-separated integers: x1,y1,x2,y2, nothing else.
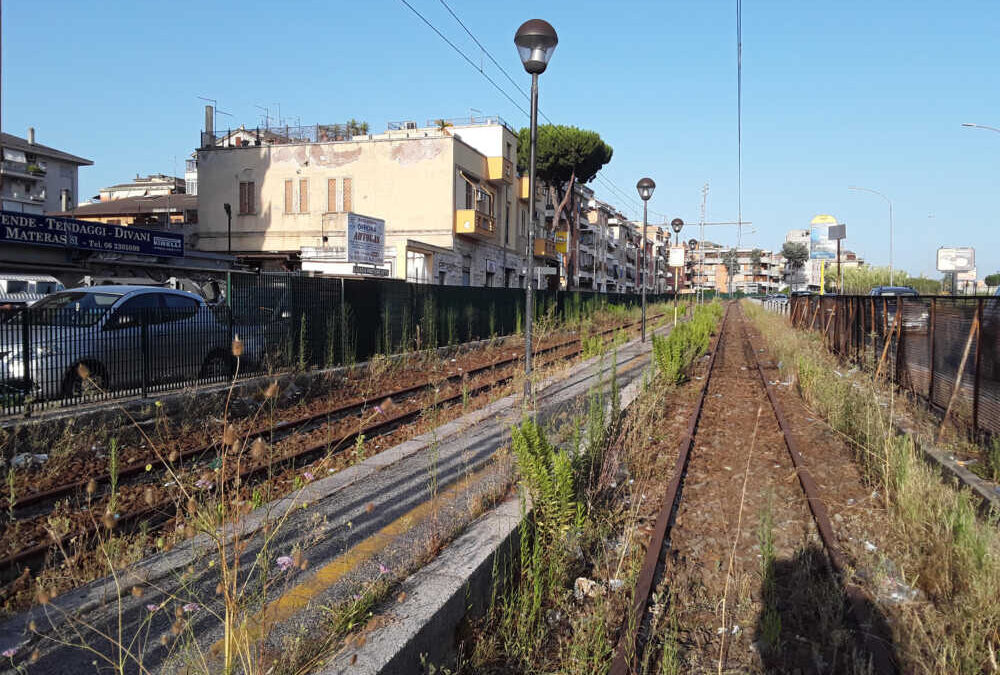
514,19,559,404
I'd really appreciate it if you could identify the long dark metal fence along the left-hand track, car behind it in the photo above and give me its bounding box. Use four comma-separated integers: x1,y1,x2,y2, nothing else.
0,274,669,415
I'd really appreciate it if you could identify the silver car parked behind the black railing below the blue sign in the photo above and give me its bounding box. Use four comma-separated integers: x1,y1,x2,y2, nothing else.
0,286,287,399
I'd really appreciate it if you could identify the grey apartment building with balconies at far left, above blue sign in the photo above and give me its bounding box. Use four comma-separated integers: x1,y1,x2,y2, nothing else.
0,127,93,214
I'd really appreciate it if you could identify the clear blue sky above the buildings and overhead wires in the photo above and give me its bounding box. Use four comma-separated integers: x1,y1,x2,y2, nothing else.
2,0,1000,276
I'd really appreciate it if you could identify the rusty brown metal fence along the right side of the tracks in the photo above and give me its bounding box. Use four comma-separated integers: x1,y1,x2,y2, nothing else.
787,296,1000,436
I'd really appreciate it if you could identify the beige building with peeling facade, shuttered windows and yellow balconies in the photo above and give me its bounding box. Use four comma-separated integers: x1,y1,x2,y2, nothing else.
194,117,554,287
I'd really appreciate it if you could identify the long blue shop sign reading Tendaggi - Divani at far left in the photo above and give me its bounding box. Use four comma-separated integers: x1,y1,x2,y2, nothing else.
0,211,184,256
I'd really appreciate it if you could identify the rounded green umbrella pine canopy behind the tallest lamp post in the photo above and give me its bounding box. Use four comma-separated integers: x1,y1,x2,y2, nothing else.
517,124,614,185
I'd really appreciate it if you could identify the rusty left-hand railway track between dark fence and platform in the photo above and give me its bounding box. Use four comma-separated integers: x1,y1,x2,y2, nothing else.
0,315,663,597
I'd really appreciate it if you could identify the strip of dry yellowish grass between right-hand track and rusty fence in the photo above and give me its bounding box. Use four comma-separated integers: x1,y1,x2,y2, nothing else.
746,305,1000,673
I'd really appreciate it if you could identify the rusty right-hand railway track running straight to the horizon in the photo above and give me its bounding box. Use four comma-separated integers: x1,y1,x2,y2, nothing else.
610,304,897,675
